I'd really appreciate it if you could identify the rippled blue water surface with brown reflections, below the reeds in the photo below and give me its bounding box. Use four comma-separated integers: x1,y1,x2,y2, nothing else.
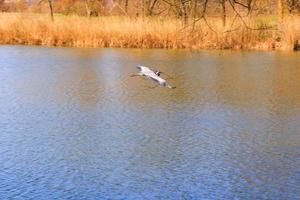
0,46,300,199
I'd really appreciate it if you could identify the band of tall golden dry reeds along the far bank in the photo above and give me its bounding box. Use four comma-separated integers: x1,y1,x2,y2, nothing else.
0,13,300,50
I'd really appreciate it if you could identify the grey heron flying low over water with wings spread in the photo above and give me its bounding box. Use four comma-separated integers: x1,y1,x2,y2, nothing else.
131,65,176,89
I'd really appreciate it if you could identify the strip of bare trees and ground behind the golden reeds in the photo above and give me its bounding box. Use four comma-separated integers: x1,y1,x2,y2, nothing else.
0,0,300,21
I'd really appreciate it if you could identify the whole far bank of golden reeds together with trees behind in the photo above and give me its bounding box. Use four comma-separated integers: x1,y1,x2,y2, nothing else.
0,0,300,50
